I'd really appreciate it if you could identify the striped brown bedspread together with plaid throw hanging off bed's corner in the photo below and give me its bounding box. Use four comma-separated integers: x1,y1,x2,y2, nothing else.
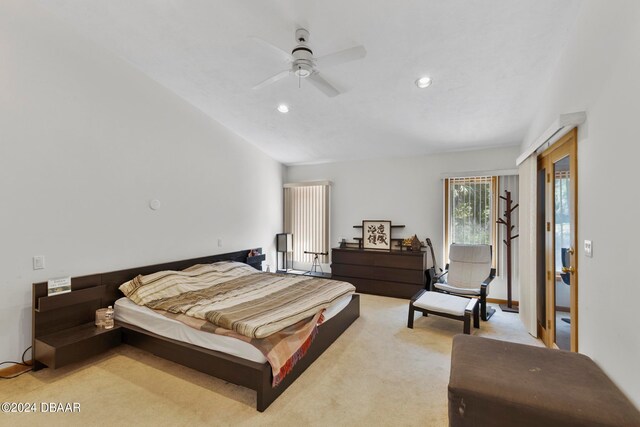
120,261,355,387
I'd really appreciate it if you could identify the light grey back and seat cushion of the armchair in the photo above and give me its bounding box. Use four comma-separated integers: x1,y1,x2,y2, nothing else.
447,244,491,291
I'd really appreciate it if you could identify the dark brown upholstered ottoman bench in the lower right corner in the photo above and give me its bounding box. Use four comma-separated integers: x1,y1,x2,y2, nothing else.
449,335,640,427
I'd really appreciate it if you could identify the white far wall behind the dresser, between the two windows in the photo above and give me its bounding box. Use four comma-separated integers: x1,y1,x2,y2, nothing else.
286,147,519,299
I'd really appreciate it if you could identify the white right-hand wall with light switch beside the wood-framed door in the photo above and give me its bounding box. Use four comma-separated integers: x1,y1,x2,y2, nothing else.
522,0,640,406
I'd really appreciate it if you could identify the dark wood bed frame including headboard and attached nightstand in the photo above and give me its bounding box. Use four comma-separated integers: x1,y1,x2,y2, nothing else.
33,249,360,412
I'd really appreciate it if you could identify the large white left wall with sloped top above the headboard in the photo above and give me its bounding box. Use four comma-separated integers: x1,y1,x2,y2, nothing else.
0,0,283,361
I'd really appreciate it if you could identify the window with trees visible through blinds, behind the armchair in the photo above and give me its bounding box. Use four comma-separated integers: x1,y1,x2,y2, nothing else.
444,176,498,267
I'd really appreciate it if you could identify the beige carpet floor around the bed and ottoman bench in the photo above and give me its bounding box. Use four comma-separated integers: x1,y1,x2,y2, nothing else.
0,295,541,426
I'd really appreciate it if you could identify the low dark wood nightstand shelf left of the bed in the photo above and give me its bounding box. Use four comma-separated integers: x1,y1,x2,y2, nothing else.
34,322,122,369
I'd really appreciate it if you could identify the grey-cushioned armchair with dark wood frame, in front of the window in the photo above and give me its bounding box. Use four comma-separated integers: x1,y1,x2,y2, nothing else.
431,243,496,320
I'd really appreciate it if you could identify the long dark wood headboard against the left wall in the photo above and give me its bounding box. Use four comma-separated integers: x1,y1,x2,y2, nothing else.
32,248,265,360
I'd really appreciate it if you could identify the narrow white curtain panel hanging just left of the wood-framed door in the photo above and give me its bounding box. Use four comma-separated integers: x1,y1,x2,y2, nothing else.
517,154,538,337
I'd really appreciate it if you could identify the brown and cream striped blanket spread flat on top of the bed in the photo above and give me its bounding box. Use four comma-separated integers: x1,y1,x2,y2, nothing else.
120,261,355,338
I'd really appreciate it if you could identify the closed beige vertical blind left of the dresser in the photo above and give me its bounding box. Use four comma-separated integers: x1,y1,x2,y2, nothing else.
284,183,330,266
